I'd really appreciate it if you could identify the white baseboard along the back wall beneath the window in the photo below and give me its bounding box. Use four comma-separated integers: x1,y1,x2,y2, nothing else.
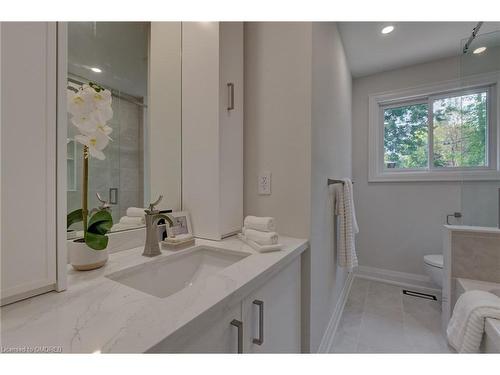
355,266,441,298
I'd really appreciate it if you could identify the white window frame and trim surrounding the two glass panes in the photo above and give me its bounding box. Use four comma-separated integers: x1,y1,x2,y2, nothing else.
368,72,500,182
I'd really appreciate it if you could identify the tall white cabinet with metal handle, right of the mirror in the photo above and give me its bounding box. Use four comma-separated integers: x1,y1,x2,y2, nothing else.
182,22,243,240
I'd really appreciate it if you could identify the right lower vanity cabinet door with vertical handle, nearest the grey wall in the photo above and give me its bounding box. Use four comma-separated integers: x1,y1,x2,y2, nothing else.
242,257,301,353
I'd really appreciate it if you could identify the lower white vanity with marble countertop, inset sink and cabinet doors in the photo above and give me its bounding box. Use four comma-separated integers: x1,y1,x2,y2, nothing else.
1,237,308,353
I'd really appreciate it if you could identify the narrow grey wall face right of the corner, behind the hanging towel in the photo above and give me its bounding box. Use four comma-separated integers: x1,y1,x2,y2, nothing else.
310,22,351,351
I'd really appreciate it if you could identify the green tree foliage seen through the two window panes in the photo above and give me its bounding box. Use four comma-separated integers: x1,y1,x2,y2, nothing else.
384,91,488,169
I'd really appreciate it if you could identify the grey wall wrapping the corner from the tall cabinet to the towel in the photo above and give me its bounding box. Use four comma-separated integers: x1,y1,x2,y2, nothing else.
244,22,351,352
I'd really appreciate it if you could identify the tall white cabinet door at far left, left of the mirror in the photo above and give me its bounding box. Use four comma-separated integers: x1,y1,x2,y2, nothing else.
0,22,57,305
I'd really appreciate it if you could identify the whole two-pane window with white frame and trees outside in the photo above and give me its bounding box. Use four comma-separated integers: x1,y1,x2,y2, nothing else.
370,78,500,181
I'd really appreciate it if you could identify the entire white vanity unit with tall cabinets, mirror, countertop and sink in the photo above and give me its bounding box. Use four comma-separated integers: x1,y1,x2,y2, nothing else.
1,22,286,353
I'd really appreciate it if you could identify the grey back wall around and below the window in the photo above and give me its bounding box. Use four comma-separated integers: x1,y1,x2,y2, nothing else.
352,58,461,275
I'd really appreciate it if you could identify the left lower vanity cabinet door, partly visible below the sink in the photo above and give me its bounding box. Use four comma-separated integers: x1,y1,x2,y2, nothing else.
149,303,243,353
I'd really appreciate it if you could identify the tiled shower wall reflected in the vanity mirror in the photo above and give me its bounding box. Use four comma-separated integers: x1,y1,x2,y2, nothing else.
67,97,144,228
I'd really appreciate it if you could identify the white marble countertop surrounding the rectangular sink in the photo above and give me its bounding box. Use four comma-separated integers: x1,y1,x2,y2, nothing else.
0,236,309,353
